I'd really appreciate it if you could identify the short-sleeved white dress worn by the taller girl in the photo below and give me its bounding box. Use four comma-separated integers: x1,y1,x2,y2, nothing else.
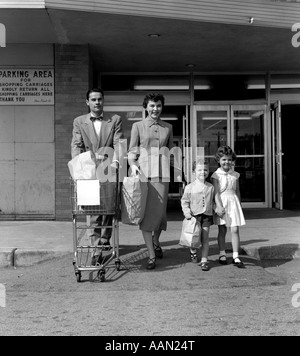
211,168,246,227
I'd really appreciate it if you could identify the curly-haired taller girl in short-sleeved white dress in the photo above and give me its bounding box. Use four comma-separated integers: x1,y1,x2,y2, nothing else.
211,146,245,268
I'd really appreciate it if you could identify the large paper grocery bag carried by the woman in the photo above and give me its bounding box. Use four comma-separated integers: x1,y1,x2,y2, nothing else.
121,175,148,225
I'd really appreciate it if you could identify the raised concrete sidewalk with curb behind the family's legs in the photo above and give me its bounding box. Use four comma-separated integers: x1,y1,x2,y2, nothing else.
0,209,300,268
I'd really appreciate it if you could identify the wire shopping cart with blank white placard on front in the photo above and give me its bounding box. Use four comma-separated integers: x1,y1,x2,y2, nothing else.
71,174,121,282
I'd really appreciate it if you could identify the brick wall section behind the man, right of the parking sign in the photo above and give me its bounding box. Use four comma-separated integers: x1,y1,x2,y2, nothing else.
55,45,91,220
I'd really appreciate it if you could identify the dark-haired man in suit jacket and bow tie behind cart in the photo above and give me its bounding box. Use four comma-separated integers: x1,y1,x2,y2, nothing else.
71,88,123,262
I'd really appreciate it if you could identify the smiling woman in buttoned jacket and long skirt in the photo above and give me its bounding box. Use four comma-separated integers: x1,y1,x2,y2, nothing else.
128,93,173,269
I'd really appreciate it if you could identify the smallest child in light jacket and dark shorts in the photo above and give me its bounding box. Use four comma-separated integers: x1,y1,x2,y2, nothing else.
179,159,214,271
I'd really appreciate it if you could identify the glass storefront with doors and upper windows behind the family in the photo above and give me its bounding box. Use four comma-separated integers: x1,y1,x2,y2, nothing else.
103,73,300,209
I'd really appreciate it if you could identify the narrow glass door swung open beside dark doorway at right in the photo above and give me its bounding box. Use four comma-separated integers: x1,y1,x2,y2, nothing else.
271,101,283,210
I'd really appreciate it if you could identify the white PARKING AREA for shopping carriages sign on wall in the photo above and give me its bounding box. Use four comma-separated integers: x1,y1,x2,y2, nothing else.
0,68,54,105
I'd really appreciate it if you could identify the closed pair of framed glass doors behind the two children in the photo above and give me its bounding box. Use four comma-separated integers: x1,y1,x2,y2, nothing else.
191,105,268,207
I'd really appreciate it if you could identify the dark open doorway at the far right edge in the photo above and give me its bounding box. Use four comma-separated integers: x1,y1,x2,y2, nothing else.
281,105,300,210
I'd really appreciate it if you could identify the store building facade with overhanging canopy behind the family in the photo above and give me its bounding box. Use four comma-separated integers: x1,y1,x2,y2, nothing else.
0,0,300,220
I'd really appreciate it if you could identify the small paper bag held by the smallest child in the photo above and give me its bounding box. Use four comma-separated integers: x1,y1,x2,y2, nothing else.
179,217,201,248
